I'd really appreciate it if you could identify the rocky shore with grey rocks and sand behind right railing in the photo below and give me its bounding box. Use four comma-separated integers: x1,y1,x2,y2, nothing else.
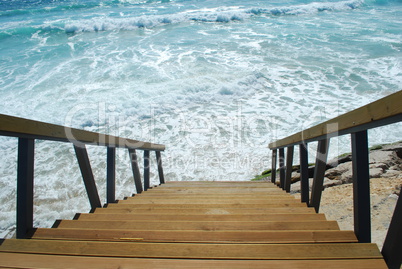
265,141,402,249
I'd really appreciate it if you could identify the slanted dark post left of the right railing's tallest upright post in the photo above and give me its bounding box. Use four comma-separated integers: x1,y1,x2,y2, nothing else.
310,138,329,213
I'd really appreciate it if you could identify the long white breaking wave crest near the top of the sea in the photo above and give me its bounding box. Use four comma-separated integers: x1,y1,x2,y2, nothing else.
0,0,363,34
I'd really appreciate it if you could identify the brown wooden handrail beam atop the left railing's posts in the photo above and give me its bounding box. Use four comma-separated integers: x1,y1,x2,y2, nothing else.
0,114,165,151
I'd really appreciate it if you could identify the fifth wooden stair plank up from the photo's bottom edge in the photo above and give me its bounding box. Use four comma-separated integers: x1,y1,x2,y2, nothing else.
76,213,326,221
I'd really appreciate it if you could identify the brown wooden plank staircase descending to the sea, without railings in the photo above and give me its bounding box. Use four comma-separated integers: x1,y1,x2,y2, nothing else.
0,182,387,269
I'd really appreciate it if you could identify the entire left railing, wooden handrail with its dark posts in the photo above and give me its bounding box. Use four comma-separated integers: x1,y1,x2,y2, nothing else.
0,114,165,238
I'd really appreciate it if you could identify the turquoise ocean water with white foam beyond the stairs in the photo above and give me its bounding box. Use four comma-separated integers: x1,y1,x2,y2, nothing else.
0,0,402,234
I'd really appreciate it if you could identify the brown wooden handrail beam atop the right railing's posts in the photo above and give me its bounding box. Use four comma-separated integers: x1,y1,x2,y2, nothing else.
269,91,402,149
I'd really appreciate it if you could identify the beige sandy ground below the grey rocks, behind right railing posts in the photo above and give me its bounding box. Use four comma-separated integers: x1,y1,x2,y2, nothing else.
293,174,402,250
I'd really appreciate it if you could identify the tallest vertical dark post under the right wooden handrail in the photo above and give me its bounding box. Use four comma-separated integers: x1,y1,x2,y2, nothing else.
351,130,371,243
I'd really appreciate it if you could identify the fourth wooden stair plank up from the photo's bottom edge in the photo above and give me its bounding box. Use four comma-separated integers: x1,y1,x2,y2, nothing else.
53,220,339,231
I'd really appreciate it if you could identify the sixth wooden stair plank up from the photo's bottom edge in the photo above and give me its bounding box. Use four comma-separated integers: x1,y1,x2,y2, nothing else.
94,204,315,215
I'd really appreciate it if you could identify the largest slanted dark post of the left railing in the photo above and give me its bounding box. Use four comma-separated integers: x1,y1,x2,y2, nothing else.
74,144,102,209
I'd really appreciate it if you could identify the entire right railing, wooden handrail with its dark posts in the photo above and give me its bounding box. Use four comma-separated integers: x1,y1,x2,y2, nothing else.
269,91,402,269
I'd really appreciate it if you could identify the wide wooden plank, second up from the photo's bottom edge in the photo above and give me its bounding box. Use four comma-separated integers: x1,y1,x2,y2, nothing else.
0,239,382,260
